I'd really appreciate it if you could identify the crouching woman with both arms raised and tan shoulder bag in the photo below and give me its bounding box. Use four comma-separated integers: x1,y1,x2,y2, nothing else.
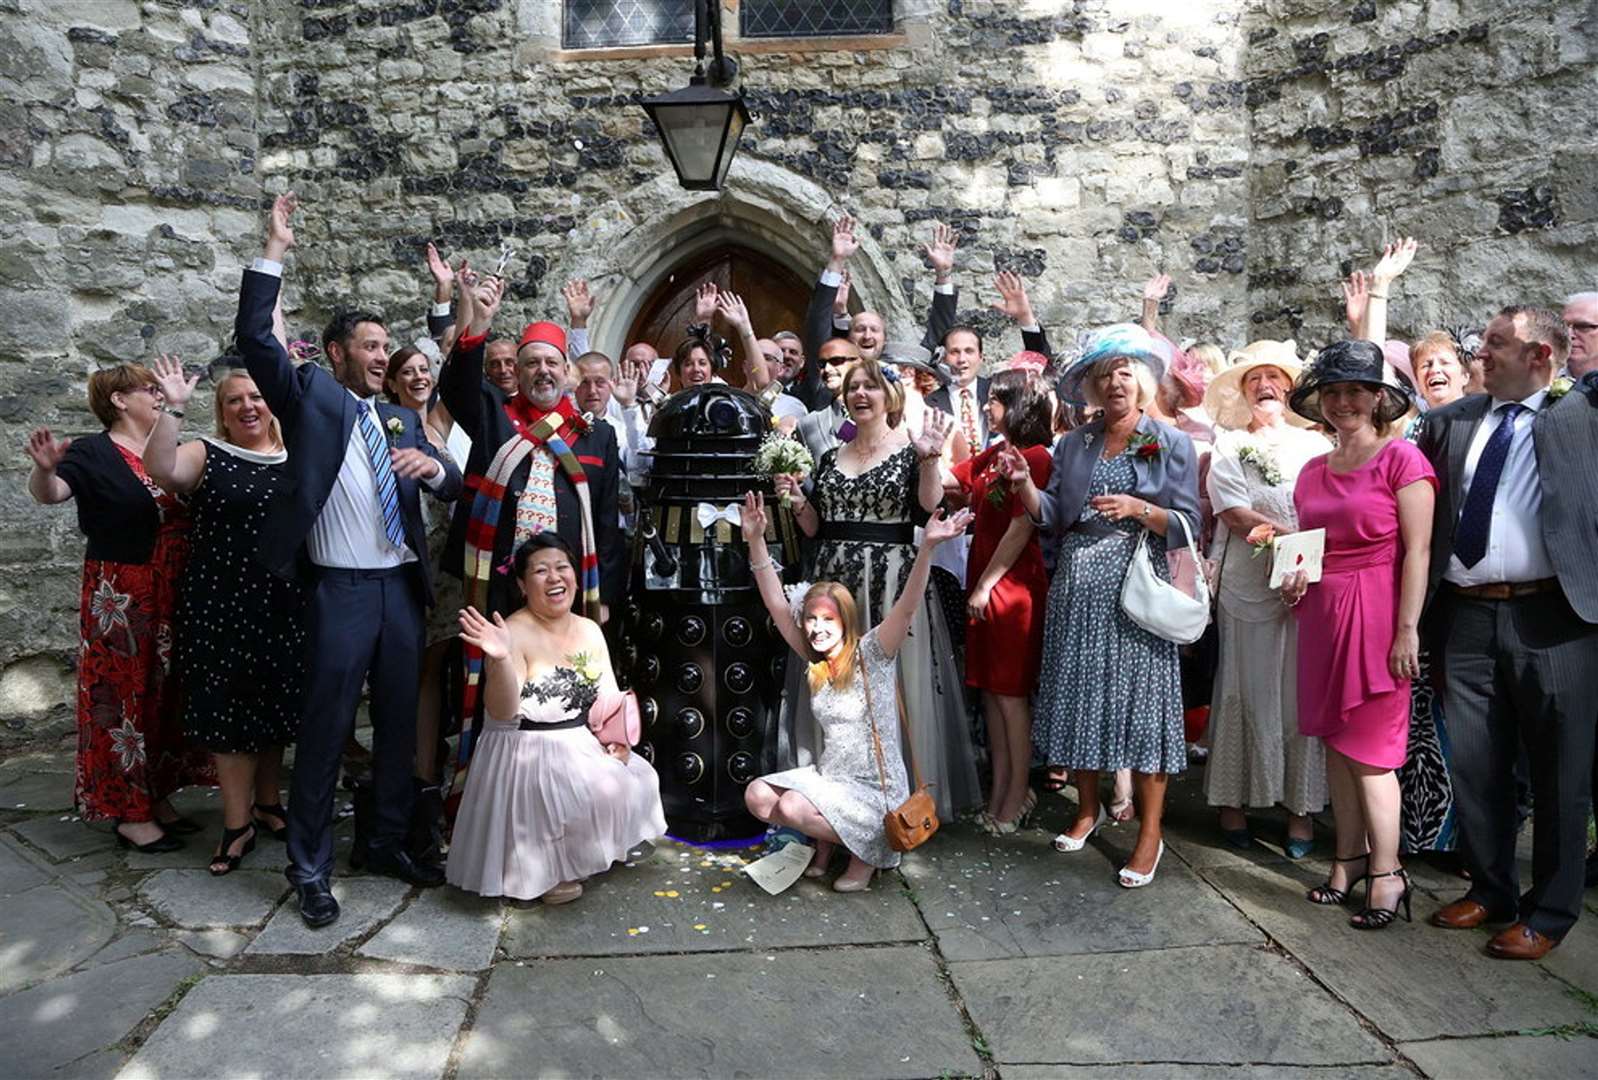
743,494,972,893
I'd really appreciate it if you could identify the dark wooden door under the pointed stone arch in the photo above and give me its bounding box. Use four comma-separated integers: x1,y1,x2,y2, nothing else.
626,244,812,388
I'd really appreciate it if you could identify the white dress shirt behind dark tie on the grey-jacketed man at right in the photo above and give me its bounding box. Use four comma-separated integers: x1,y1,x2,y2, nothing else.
1443,388,1553,585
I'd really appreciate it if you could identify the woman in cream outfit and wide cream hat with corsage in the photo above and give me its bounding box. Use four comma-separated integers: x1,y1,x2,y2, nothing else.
1205,340,1331,858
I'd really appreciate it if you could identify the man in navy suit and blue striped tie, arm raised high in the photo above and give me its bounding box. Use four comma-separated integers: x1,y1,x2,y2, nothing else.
235,193,460,927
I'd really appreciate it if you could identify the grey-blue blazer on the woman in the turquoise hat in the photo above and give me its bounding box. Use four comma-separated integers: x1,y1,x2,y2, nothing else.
1039,414,1199,548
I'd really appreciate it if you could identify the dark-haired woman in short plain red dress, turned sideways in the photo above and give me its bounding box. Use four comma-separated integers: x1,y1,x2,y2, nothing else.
949,371,1053,836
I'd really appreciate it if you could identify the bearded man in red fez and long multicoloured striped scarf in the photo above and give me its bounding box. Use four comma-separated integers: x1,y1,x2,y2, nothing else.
438,278,626,734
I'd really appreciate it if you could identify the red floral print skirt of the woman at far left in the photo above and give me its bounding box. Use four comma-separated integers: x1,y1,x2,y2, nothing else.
77,536,216,821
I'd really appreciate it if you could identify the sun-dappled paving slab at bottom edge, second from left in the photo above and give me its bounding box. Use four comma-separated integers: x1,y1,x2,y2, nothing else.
120,975,473,1080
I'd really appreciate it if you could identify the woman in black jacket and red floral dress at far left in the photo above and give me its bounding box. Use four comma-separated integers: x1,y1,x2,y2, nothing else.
27,364,209,852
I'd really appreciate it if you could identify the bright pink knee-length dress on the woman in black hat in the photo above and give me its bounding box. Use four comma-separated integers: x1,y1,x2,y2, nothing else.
1293,439,1437,768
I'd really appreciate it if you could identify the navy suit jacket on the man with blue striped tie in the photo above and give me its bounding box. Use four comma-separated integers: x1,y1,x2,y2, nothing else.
233,270,460,606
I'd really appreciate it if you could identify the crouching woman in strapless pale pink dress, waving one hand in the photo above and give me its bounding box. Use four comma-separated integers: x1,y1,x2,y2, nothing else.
446,532,666,904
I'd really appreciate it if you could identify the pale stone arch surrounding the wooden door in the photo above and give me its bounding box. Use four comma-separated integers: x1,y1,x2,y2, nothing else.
548,158,919,356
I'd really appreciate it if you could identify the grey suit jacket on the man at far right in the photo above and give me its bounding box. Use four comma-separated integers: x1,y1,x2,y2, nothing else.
1416,383,1598,623
